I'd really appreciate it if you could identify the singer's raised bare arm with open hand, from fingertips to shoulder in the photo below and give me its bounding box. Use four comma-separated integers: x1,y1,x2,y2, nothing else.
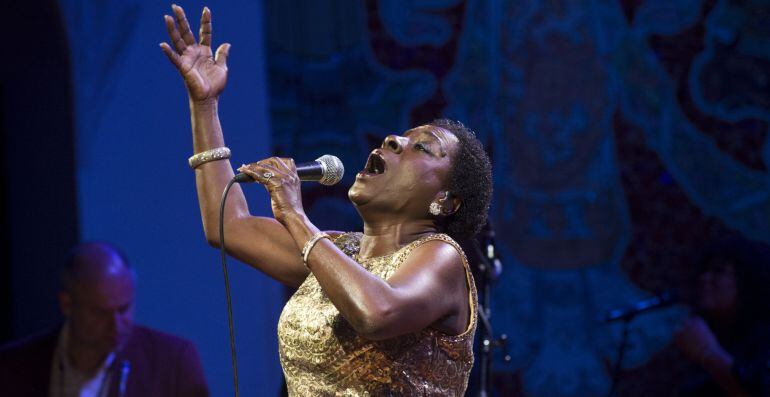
160,6,308,286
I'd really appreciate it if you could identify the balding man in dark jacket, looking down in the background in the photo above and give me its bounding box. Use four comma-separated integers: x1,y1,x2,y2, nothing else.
0,243,209,397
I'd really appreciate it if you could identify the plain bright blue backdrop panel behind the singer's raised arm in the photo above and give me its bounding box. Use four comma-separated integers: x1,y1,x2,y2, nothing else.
62,1,283,396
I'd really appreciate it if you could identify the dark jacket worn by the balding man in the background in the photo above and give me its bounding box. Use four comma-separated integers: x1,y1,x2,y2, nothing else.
0,326,209,397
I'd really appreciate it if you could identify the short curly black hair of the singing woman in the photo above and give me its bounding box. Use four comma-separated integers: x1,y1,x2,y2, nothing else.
430,119,492,240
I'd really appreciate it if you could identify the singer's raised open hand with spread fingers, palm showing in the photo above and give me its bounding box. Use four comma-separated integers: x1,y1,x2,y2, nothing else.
160,5,230,102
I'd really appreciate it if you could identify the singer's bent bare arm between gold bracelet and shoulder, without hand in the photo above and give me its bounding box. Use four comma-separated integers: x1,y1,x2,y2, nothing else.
308,230,471,340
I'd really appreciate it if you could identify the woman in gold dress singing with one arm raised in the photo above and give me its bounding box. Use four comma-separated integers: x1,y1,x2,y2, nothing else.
161,6,492,396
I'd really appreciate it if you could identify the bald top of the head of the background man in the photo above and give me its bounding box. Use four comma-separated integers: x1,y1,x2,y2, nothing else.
61,243,136,292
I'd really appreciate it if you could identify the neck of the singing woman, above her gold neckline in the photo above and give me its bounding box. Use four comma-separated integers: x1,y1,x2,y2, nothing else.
359,220,438,258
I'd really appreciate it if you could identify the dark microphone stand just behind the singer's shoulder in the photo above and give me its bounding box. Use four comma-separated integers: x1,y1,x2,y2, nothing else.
475,223,511,397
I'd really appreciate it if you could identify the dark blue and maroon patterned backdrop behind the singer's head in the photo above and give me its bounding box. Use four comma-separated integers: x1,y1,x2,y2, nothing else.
265,0,770,396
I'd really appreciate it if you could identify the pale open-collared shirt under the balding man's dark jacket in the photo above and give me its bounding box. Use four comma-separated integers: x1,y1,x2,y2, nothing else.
48,323,115,397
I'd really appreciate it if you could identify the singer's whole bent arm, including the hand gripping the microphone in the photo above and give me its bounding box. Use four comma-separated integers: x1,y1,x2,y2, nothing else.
241,157,470,339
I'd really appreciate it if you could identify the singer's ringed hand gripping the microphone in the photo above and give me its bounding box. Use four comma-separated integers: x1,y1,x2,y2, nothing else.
238,157,305,226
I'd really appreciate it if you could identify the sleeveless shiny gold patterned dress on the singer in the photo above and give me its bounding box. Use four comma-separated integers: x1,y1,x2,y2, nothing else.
278,233,478,396
